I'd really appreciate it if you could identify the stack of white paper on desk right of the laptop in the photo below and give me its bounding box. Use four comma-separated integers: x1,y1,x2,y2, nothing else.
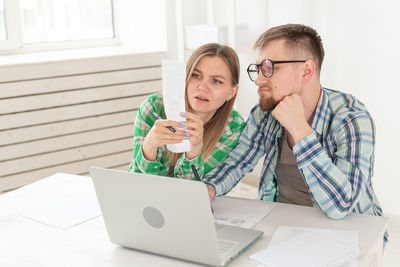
250,227,360,267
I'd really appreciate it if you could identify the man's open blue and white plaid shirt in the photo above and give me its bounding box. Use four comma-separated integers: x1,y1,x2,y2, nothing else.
203,88,382,219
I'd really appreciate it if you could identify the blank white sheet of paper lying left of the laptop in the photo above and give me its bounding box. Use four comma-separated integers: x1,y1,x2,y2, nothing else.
0,173,101,229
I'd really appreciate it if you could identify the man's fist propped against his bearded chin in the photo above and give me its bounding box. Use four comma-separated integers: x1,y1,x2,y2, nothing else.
272,94,312,144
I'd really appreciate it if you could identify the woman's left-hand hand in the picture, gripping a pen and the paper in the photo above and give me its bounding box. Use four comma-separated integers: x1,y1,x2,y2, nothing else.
143,120,185,161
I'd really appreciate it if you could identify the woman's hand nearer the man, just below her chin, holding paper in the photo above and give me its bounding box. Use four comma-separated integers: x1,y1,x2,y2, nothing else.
185,112,204,159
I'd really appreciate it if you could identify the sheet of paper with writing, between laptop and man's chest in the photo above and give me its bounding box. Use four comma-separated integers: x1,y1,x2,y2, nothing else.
212,196,275,229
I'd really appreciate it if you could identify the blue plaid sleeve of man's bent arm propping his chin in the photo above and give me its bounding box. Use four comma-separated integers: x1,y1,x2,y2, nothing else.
293,113,375,219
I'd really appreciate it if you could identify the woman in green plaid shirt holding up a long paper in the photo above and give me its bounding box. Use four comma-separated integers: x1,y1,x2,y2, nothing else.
129,43,244,179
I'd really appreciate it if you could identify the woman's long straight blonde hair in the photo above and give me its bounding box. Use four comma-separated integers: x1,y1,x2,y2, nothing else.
167,43,240,166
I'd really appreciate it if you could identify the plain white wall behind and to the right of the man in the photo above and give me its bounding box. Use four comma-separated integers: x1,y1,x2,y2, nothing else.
268,0,400,218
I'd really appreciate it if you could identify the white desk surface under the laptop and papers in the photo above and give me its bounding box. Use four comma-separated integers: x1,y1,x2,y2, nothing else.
0,175,388,267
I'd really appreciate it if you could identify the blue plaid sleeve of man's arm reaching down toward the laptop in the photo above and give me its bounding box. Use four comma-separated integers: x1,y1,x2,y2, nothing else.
203,108,272,196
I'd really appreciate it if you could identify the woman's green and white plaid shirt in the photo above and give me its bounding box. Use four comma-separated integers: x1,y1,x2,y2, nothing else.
129,93,245,179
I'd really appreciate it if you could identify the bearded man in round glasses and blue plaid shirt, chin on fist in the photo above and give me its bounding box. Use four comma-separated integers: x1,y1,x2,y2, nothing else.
203,24,382,222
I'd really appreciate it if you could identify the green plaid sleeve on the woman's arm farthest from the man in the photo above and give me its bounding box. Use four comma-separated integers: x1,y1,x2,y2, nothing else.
129,95,168,176
